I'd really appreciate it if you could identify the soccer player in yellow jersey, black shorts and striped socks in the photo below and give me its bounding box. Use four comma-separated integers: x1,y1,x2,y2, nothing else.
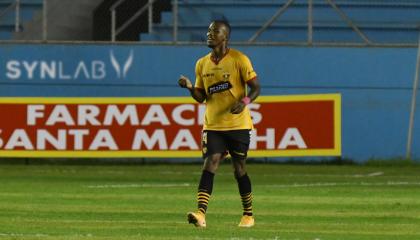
178,21,260,227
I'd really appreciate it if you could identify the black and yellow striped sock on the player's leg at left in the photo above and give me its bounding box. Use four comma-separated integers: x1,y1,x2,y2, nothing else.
197,170,214,214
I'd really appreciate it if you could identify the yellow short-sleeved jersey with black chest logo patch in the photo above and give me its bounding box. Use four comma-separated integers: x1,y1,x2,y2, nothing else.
195,48,257,131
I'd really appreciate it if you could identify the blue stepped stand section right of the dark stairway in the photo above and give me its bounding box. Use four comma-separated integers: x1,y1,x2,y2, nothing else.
141,0,420,43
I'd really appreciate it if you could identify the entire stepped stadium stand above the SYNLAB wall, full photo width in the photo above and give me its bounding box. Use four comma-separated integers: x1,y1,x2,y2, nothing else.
0,0,420,44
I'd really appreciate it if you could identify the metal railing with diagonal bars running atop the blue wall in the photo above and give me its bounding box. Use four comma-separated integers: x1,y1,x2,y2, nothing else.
0,0,420,47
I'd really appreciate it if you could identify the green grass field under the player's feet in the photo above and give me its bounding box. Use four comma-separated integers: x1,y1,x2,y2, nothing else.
0,164,420,240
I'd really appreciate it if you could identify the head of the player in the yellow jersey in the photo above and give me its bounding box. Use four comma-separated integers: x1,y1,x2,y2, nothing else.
207,20,230,48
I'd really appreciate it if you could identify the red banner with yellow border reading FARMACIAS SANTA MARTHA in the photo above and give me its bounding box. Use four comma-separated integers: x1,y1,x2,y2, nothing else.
0,94,341,158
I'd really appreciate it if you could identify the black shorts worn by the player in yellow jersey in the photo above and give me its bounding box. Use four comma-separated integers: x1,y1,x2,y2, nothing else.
202,129,251,159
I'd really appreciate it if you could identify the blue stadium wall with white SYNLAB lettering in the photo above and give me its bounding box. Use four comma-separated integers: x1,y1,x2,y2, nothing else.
0,44,420,162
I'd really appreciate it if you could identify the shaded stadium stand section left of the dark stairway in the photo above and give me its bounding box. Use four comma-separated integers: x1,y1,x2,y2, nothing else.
0,0,103,40
